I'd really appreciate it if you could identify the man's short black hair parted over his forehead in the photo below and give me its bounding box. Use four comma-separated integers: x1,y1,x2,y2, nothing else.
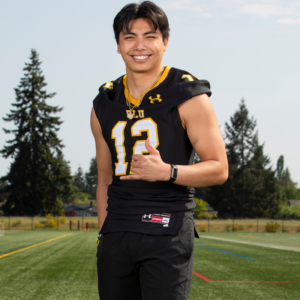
113,1,170,43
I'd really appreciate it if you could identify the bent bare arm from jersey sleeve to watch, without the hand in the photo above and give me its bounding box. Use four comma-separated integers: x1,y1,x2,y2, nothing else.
175,94,228,187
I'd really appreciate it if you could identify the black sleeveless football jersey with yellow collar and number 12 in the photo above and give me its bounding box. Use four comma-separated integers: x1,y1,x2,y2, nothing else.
93,67,211,235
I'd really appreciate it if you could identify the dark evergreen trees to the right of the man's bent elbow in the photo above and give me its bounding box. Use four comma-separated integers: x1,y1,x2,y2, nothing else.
195,100,300,218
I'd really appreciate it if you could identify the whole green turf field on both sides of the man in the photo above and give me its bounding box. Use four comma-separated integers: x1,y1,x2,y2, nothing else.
0,230,300,300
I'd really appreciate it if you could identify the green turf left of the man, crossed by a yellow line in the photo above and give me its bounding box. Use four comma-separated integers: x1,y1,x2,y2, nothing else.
0,231,98,300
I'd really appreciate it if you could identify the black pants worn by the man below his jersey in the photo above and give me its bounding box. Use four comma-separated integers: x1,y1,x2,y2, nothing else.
97,218,194,300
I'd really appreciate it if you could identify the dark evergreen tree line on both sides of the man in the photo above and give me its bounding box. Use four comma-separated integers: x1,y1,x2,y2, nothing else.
0,49,300,218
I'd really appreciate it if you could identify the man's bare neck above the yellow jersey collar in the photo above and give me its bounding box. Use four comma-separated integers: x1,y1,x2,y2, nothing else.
126,66,163,99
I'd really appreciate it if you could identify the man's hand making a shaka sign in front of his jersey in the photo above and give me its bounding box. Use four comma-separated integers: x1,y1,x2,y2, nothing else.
120,138,171,182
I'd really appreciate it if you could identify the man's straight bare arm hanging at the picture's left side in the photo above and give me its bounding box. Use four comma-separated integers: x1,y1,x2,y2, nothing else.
91,108,113,229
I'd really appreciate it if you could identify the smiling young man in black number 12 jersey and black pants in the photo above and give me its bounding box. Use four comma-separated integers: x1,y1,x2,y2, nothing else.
91,1,228,300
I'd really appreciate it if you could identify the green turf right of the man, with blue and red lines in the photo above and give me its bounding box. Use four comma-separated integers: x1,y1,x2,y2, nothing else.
189,233,300,300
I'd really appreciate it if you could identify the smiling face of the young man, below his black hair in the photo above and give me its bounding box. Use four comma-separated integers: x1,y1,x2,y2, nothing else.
118,18,168,73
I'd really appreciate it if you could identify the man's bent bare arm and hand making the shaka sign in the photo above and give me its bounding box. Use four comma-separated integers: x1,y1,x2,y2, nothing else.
120,94,228,187
